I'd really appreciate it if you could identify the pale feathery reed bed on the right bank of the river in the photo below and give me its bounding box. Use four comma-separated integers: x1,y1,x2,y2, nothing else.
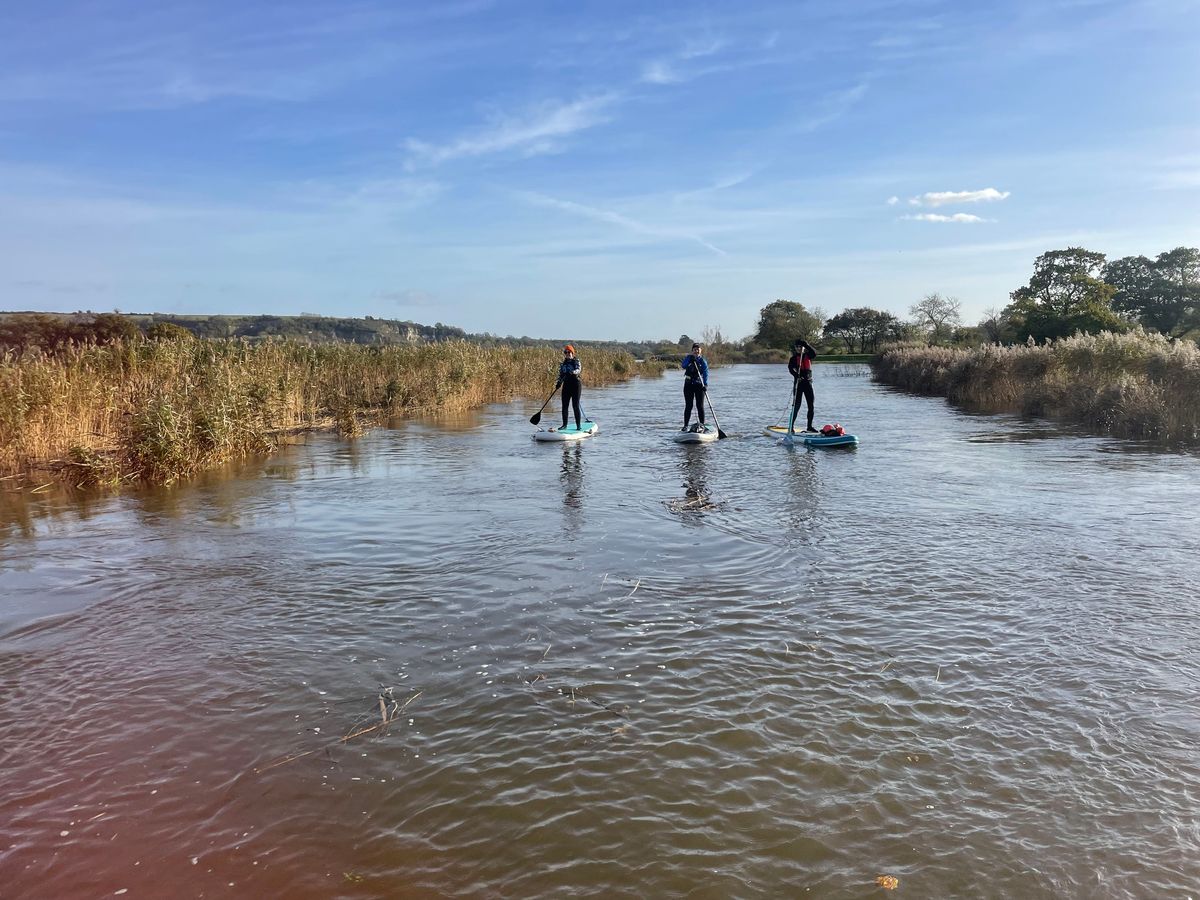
872,331,1200,444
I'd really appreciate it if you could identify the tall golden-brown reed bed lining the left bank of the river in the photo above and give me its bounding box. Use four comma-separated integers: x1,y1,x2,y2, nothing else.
0,341,660,484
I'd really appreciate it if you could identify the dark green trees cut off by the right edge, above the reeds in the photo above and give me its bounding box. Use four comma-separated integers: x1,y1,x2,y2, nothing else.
1103,247,1200,337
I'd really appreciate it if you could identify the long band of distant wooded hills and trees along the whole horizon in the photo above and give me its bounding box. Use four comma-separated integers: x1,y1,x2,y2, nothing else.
7,247,1200,362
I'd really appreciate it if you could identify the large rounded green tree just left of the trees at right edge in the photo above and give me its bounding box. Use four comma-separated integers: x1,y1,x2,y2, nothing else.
1004,247,1127,341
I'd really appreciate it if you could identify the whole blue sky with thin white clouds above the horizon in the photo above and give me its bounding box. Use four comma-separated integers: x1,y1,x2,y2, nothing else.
0,0,1200,340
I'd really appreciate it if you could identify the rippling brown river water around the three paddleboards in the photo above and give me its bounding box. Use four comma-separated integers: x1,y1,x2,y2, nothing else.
0,366,1200,898
